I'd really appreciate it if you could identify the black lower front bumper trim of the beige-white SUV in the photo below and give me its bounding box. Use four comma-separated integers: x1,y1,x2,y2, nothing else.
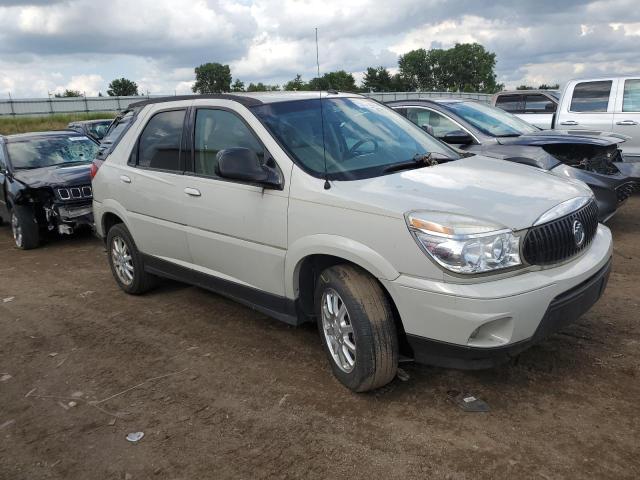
407,258,612,370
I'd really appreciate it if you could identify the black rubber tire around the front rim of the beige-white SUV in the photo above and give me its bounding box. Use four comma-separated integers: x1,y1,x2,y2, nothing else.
315,265,398,392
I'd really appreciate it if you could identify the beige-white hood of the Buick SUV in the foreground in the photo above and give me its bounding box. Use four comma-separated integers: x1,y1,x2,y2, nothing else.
332,155,592,230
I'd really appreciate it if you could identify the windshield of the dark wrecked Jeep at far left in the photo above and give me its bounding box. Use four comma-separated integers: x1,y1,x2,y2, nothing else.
7,136,98,170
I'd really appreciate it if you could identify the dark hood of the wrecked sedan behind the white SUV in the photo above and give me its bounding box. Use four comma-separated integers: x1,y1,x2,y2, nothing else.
496,130,628,147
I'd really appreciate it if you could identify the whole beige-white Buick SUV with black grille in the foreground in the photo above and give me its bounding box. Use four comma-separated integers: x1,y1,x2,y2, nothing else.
93,92,612,391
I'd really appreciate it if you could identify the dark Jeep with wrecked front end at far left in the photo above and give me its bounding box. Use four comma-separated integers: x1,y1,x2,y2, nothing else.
0,131,98,250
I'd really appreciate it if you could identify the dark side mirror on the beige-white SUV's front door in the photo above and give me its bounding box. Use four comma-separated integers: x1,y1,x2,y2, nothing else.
216,148,283,190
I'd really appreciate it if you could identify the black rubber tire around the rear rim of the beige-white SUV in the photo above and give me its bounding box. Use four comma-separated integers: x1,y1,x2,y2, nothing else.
107,223,158,295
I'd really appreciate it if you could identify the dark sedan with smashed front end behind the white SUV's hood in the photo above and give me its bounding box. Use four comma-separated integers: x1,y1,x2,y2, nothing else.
388,99,640,222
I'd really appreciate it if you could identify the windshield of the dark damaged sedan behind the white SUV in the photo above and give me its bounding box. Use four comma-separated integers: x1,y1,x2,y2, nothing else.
445,102,539,137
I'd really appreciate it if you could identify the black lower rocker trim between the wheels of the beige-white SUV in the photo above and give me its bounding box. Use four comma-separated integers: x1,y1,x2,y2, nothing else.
142,253,304,326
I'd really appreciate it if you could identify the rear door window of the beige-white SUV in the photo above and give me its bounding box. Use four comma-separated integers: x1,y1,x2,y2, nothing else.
138,110,185,172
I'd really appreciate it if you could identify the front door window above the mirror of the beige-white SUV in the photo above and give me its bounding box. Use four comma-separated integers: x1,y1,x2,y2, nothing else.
194,109,264,176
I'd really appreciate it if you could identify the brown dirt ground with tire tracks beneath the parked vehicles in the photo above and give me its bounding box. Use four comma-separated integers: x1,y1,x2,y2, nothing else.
0,197,640,480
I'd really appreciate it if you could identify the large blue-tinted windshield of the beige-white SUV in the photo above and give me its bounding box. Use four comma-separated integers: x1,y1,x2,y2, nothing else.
252,98,459,180
